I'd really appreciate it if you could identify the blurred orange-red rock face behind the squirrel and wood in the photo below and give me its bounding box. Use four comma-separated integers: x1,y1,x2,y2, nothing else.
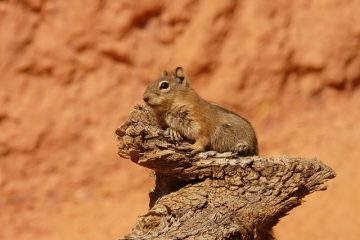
0,0,360,240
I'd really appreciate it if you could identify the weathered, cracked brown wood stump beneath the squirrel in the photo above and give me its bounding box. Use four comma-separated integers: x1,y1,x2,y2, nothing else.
116,105,335,240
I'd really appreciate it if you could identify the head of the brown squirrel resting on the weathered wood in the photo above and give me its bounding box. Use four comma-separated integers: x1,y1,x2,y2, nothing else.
144,67,190,112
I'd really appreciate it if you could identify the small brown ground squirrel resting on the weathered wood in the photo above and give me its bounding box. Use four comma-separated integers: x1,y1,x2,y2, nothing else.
143,67,258,156
